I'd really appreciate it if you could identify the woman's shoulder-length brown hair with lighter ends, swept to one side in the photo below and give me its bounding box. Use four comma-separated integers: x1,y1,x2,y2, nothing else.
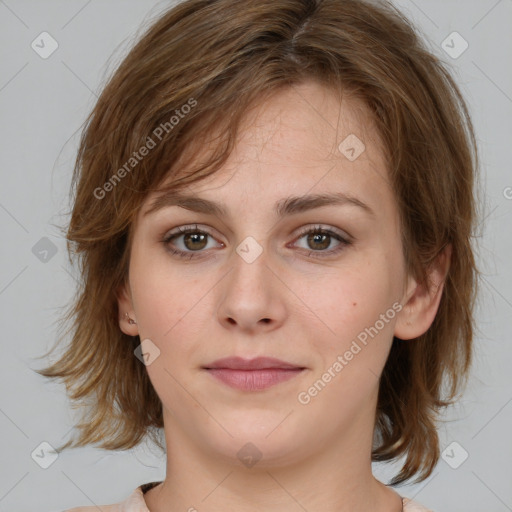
35,0,478,485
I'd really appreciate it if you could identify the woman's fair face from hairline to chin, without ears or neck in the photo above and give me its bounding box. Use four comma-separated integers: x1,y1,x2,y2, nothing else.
119,83,436,464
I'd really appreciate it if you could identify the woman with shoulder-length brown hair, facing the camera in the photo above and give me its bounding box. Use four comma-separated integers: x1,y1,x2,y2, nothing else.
37,0,477,512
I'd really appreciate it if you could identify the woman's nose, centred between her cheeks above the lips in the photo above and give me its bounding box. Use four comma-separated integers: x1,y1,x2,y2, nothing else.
217,242,290,334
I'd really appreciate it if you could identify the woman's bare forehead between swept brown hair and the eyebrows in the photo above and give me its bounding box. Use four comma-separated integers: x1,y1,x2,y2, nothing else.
142,82,391,220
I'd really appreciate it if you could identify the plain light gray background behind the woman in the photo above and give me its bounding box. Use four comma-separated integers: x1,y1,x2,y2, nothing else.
0,0,512,512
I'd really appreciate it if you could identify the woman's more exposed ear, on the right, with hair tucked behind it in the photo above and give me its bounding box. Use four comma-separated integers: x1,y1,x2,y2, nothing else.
394,244,452,340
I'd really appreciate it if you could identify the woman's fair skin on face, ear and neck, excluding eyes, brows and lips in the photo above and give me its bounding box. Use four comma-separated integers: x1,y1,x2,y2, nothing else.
119,82,449,512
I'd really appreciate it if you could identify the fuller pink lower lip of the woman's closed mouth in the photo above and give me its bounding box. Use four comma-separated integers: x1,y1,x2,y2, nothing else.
208,368,303,391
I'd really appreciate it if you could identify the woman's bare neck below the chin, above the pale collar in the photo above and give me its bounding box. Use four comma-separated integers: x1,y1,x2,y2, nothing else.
144,411,402,512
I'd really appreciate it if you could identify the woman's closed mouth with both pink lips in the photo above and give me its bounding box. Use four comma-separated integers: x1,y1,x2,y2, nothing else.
202,357,306,391
